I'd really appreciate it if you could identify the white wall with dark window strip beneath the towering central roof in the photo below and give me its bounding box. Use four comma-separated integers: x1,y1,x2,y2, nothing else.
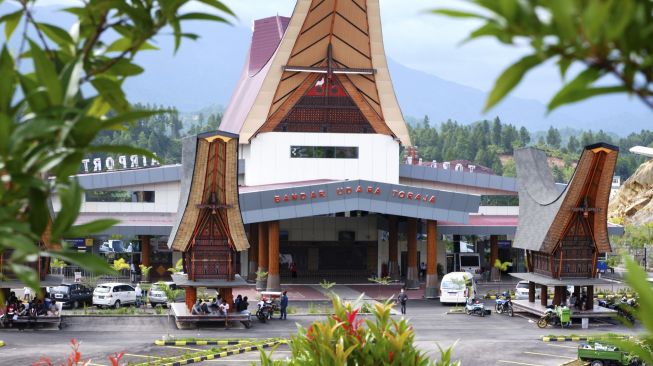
240,132,399,186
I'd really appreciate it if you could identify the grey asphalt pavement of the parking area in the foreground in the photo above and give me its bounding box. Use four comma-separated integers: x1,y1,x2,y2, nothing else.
0,300,637,366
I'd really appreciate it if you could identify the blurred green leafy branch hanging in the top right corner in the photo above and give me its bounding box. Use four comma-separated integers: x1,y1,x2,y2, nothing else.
433,0,653,111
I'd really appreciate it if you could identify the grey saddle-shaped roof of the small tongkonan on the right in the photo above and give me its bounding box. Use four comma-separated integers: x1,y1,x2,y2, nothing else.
514,143,619,253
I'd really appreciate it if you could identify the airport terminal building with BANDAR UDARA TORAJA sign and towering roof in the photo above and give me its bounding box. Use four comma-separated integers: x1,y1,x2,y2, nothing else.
53,0,621,296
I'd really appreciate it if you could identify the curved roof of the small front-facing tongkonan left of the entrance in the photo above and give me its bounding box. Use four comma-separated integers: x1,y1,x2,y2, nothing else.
168,131,249,251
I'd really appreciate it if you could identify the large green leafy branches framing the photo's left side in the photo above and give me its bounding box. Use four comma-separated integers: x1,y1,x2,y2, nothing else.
0,0,233,290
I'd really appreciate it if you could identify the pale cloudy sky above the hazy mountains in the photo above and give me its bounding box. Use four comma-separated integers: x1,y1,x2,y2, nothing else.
216,0,560,102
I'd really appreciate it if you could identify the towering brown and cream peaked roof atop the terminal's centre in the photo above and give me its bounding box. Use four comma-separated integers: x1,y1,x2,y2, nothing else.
221,0,410,145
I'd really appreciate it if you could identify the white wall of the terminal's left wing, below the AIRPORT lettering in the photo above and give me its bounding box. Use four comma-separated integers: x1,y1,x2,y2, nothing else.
52,182,181,213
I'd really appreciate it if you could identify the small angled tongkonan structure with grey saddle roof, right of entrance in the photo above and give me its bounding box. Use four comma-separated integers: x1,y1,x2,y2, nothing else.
512,143,619,310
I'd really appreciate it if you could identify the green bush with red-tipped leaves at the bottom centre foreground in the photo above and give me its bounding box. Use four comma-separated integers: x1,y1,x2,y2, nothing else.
261,295,457,366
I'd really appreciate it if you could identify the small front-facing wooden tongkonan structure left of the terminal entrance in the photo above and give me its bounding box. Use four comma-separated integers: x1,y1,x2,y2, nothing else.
168,131,249,309
